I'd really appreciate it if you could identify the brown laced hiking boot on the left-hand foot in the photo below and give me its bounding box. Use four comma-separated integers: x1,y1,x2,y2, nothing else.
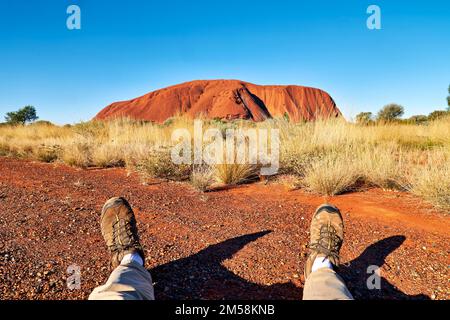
100,197,144,268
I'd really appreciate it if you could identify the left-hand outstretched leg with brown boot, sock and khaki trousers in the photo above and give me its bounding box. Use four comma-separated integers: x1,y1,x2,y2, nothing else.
89,198,155,300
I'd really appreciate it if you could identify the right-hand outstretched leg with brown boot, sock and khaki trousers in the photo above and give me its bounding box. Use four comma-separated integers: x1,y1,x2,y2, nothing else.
303,205,353,300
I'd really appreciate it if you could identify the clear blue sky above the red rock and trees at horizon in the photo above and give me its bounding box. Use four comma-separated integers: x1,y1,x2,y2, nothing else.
0,0,450,124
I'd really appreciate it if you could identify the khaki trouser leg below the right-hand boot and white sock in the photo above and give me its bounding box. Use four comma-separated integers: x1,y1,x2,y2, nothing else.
303,268,353,300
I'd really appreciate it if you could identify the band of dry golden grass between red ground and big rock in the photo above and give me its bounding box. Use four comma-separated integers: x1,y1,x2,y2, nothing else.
0,116,450,208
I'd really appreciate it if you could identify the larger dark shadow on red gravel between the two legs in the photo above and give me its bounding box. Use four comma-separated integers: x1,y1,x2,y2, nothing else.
150,231,302,300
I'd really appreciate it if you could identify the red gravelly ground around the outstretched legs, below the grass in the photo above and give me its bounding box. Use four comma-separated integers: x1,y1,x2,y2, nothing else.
0,158,450,299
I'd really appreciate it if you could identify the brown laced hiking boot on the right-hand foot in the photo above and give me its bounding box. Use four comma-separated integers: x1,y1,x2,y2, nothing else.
305,204,344,279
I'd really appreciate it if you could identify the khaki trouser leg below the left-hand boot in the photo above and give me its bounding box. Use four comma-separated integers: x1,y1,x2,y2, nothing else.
89,262,155,300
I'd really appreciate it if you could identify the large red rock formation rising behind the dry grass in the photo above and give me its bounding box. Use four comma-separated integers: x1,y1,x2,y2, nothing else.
94,80,341,123
